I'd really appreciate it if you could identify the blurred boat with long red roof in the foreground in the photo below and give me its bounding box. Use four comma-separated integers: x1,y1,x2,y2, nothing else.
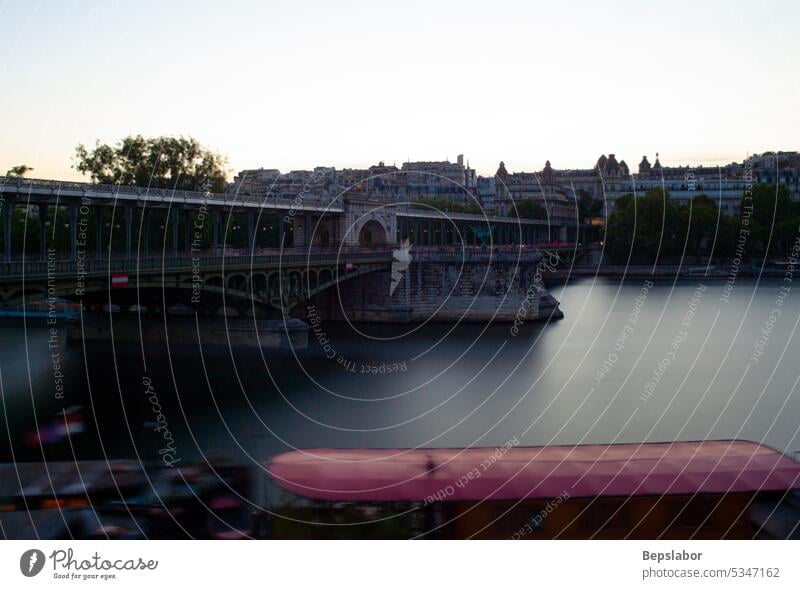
265,440,800,539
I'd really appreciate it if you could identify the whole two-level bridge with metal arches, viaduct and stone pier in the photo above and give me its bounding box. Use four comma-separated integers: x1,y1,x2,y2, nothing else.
0,177,581,321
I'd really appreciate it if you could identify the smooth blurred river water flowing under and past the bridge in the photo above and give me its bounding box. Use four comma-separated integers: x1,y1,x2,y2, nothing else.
0,280,800,462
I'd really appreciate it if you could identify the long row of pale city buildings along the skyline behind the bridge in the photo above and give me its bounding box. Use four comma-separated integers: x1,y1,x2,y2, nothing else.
231,151,800,221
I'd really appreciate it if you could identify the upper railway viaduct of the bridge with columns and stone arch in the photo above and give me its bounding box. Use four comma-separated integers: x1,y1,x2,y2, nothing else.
0,177,585,262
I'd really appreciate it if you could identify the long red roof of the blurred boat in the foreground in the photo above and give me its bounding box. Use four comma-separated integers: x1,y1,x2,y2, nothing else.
268,440,800,502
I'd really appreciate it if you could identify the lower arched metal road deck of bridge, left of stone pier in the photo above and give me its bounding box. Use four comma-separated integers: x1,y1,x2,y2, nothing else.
0,250,392,316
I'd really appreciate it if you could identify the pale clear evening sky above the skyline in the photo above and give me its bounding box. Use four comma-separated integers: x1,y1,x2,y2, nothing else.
0,0,800,179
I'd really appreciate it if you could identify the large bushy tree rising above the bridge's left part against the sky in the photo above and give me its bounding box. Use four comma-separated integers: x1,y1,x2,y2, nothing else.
72,135,227,192
